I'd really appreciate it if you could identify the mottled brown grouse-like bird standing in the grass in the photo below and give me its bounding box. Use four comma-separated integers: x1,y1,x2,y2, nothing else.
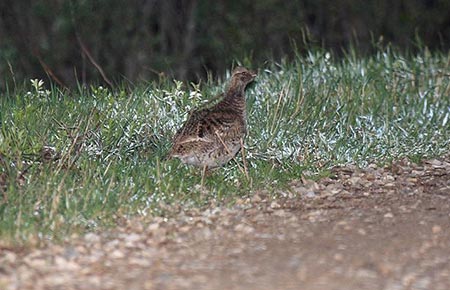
169,67,256,169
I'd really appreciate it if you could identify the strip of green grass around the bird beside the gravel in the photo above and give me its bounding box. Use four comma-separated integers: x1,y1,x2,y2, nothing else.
0,48,450,243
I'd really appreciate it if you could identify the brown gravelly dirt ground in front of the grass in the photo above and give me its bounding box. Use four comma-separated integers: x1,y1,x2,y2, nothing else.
0,156,450,290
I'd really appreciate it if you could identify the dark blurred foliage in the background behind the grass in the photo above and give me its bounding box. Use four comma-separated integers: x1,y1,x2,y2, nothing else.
0,0,450,89
